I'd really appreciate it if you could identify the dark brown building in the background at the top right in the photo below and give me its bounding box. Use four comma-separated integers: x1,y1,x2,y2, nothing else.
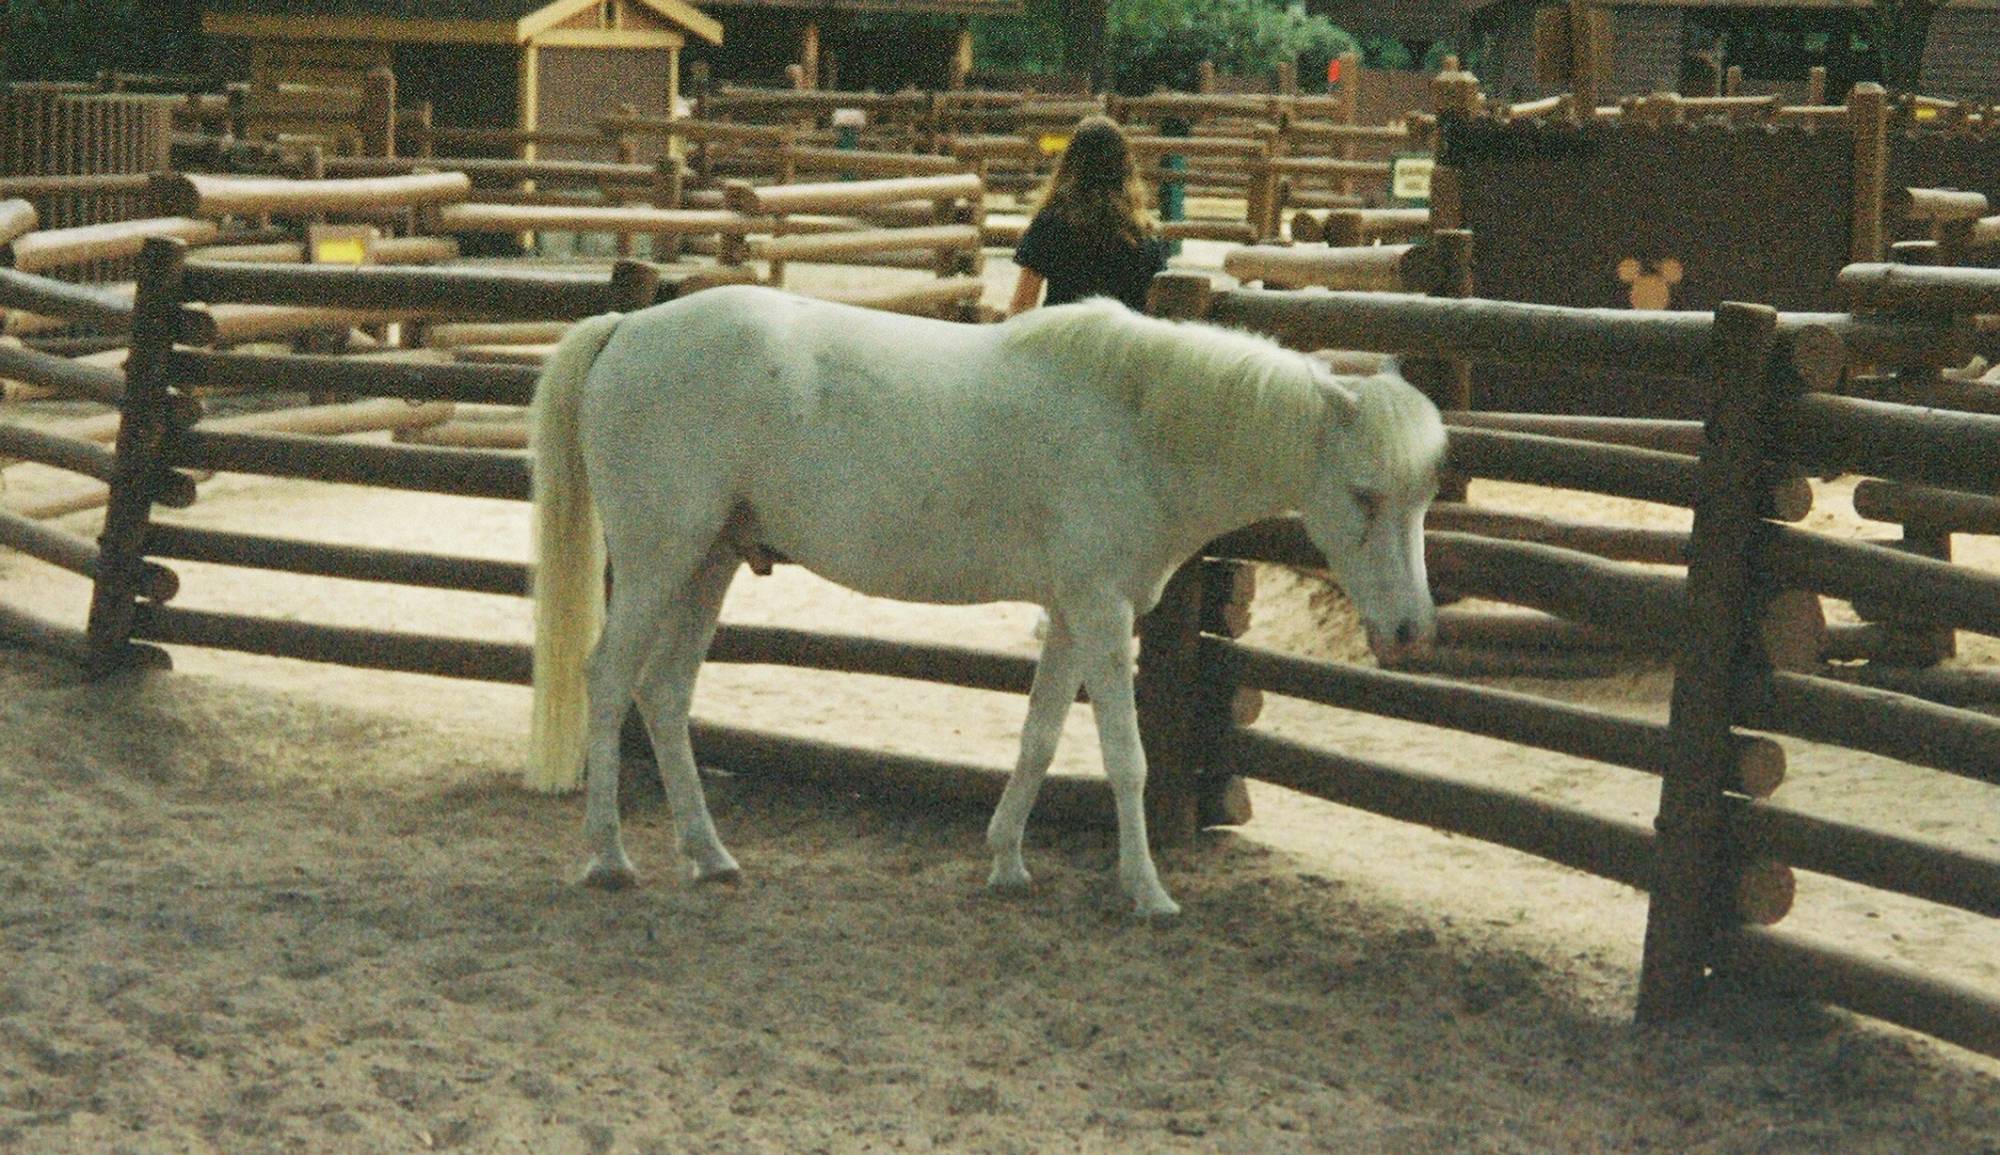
1466,0,2000,102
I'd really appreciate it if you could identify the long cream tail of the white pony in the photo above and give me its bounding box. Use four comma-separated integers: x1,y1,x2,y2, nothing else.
528,314,622,793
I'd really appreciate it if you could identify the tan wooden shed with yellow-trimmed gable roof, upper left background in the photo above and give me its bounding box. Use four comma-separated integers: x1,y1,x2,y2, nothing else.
202,0,722,152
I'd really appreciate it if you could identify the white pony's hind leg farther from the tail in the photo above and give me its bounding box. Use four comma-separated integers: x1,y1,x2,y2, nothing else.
638,544,742,881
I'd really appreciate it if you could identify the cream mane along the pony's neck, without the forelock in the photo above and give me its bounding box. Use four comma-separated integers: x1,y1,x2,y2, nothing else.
1004,298,1326,490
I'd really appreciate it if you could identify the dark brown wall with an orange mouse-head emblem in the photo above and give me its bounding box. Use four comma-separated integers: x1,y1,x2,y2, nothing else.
1440,84,2000,418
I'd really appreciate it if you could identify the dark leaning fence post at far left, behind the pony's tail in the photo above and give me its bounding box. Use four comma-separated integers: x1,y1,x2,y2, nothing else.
86,238,194,675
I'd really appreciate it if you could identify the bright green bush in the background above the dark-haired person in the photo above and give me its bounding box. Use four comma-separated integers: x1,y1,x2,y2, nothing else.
1104,0,1358,94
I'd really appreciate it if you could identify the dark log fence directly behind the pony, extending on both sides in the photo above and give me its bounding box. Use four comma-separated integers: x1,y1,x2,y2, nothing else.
7,240,2000,1053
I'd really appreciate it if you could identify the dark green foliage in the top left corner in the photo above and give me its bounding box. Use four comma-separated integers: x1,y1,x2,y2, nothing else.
6,0,200,80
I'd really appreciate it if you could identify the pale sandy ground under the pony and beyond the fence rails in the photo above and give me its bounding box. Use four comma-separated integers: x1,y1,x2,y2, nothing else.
0,237,2000,1155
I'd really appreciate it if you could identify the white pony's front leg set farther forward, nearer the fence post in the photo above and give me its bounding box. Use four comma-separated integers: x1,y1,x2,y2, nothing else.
1072,601,1180,917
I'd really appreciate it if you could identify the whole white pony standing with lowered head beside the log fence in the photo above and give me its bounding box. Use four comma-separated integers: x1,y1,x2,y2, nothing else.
530,286,1444,915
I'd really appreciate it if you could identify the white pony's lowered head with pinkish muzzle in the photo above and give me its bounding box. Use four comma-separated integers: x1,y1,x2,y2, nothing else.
1300,362,1444,657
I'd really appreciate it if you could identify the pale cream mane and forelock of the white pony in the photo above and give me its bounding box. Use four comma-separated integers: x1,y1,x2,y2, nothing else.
1004,298,1444,494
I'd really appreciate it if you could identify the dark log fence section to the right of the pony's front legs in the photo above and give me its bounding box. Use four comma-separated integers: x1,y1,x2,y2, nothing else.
1144,268,2000,1053
